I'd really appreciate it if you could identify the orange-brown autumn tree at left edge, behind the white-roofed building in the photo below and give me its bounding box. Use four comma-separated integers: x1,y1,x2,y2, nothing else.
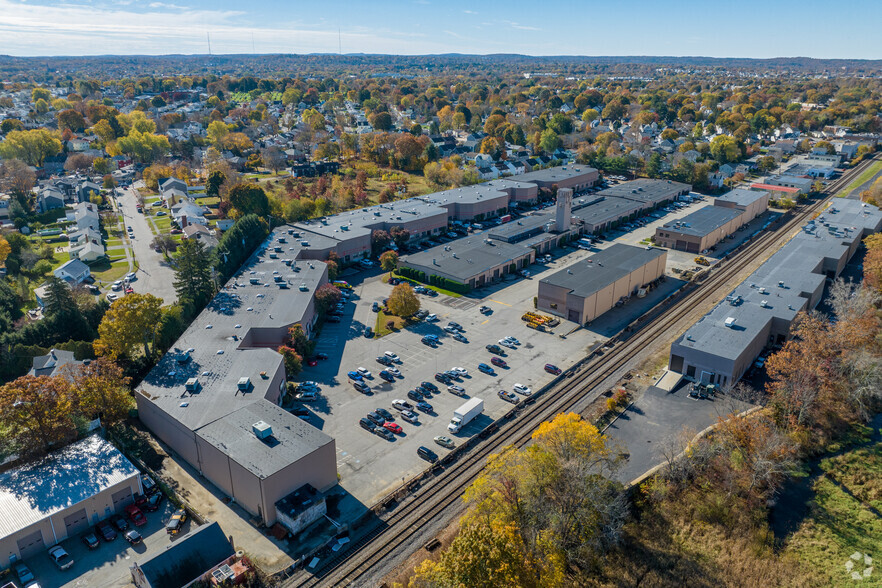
0,376,76,455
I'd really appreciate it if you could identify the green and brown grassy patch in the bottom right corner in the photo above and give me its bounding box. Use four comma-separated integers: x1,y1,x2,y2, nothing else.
786,434,882,586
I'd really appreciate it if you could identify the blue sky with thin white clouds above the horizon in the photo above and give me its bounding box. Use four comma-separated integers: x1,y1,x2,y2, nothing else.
0,0,882,59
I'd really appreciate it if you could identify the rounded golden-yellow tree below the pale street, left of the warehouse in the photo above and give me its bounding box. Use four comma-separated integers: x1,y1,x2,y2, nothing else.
95,293,162,359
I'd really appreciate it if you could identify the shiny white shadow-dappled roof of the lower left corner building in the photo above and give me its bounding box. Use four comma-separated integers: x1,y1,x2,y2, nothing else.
0,435,139,537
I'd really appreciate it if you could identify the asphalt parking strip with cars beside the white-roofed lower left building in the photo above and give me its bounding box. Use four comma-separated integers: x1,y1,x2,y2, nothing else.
15,500,193,588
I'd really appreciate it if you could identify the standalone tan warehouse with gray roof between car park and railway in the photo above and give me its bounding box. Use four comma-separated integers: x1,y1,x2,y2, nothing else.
537,243,667,324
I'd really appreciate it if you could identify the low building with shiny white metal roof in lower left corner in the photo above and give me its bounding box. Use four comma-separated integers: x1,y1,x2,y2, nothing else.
0,435,143,569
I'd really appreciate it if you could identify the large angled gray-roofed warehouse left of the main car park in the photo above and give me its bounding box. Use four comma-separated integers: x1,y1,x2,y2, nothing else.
135,227,337,525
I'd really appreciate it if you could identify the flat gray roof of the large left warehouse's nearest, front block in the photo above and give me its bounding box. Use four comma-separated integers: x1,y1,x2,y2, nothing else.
197,400,334,478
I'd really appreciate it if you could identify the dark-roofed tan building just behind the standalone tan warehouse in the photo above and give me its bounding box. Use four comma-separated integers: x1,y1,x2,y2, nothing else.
655,206,747,253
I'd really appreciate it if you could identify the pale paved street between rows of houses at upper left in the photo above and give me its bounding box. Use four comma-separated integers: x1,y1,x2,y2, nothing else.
116,187,178,304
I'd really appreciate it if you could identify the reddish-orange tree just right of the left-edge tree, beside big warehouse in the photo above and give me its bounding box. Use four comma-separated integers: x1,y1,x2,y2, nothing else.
65,357,135,426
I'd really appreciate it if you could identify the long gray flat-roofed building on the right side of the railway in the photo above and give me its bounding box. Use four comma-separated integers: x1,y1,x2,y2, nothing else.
669,199,882,387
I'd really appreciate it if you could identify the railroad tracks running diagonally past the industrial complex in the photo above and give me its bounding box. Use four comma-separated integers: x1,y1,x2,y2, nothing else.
285,158,876,588
